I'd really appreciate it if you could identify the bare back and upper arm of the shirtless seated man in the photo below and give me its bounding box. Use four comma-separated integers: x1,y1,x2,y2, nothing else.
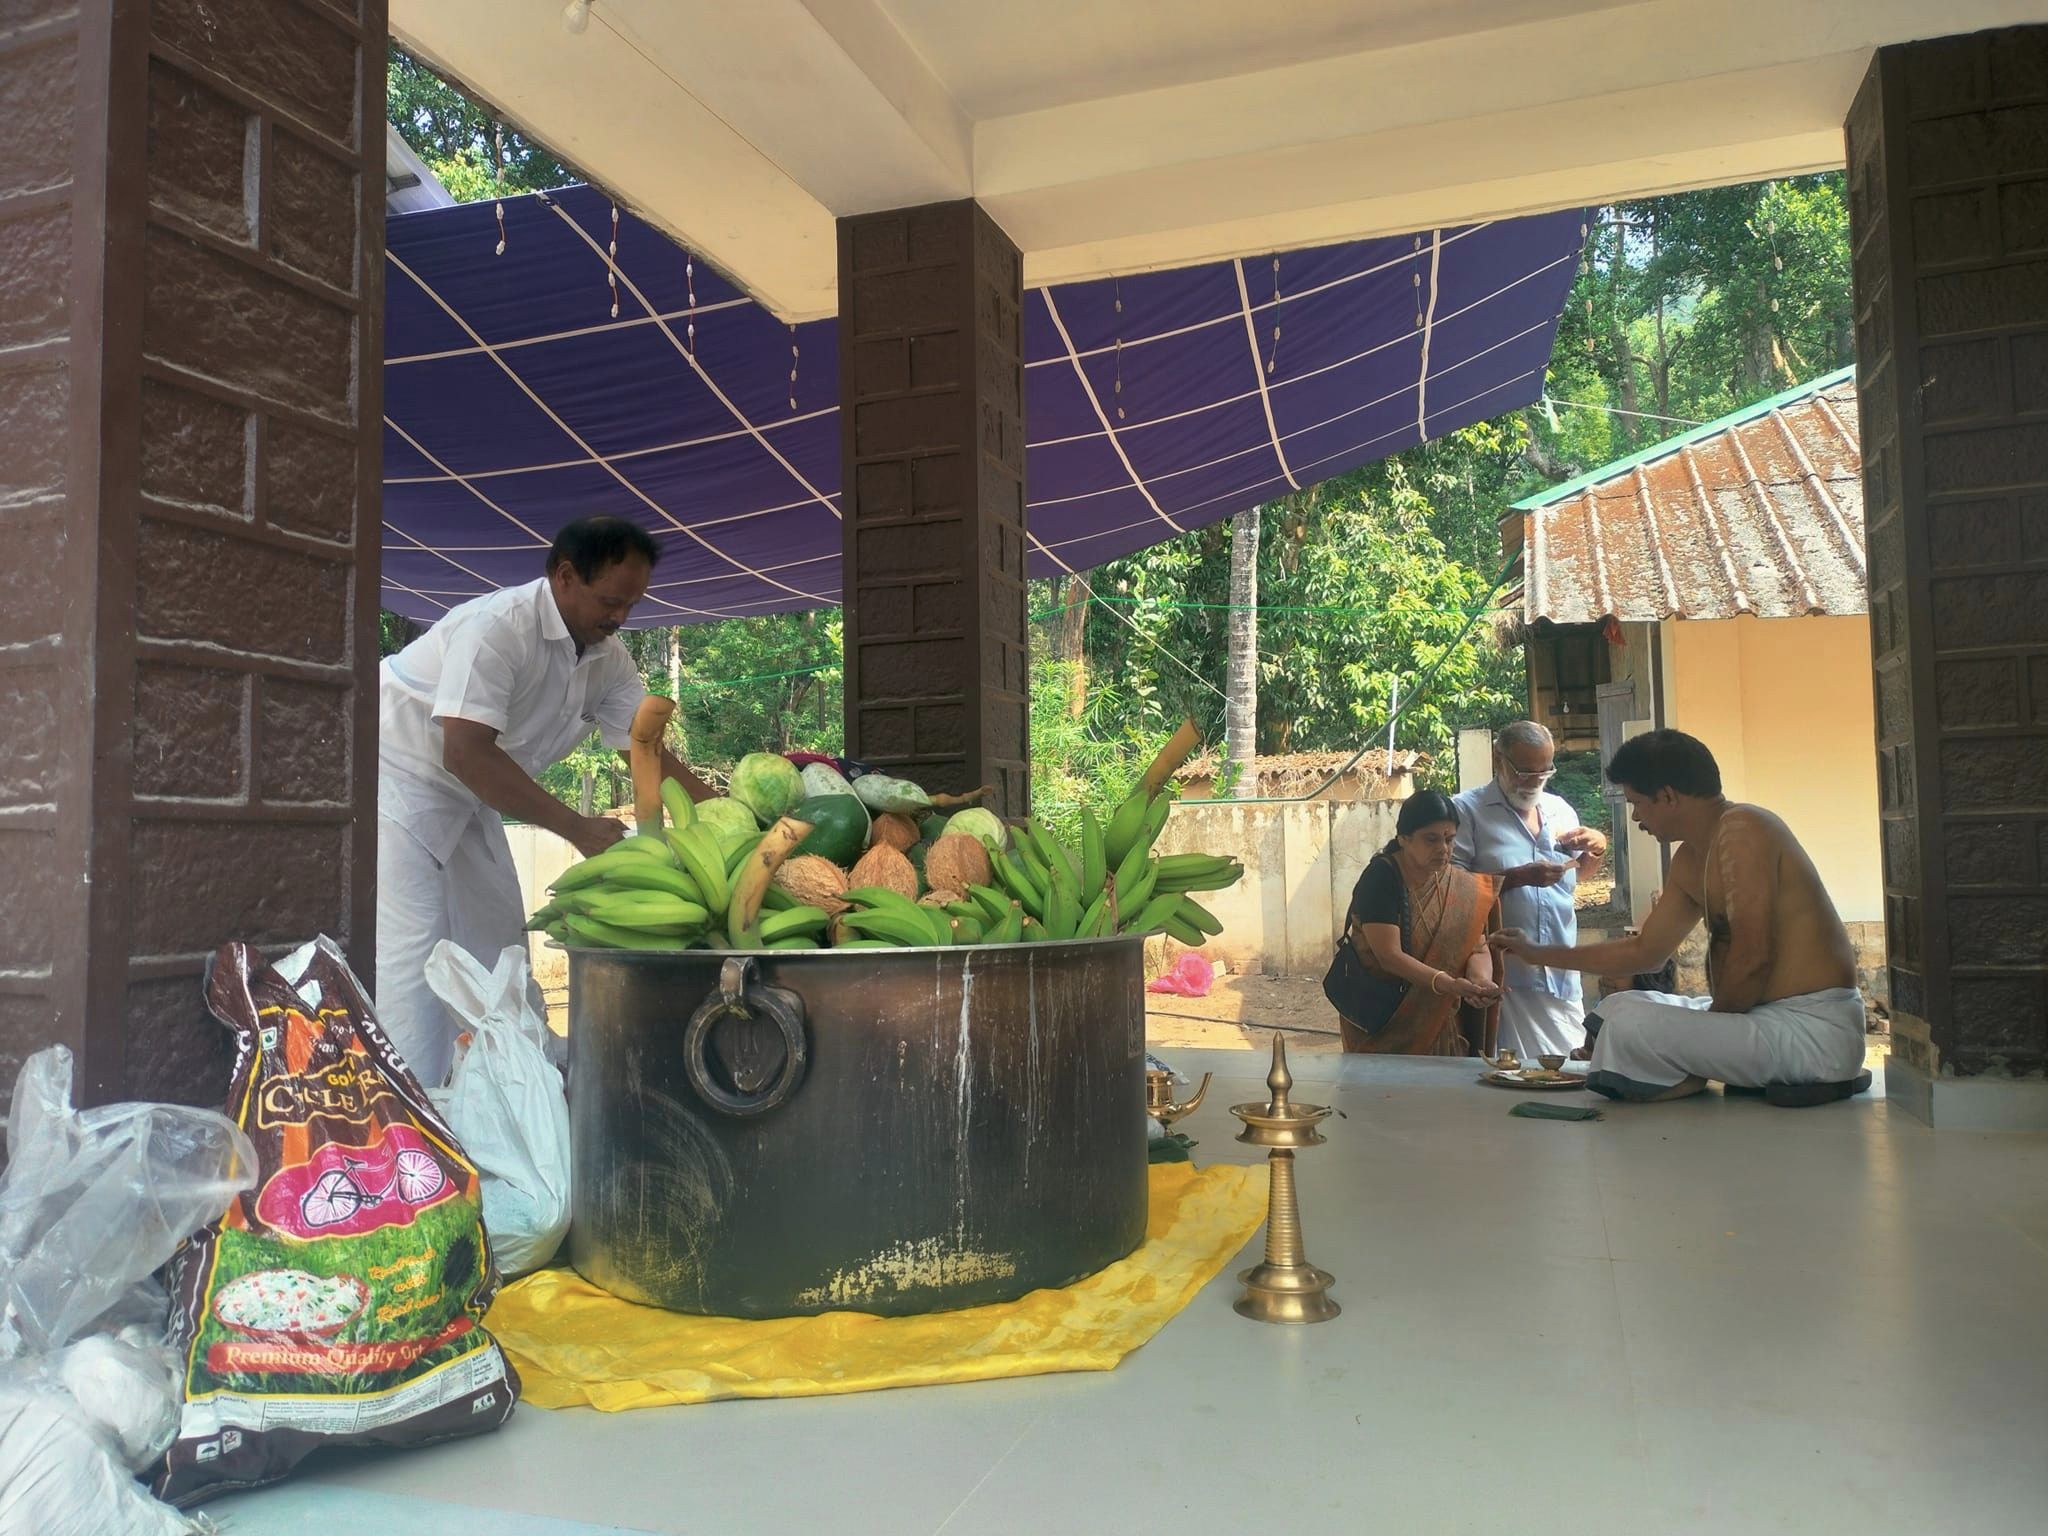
1671,805,1855,1012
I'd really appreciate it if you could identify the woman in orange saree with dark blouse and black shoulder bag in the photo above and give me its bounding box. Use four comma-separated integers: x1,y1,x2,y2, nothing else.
1323,791,1501,1057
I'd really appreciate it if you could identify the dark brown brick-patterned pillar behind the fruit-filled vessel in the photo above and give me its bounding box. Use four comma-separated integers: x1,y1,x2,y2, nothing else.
840,203,1030,815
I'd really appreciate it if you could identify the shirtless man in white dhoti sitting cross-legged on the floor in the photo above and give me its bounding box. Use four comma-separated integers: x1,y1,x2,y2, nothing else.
1493,731,1870,1104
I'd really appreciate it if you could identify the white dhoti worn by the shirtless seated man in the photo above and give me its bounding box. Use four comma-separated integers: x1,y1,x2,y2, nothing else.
1587,987,1864,1100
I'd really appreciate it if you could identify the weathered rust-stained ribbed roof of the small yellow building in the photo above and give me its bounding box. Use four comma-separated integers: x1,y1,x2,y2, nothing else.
1501,369,1866,625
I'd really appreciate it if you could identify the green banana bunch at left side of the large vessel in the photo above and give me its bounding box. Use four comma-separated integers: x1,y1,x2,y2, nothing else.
526,778,827,950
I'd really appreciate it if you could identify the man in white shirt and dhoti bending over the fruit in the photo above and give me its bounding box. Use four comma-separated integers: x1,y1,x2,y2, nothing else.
377,518,713,1087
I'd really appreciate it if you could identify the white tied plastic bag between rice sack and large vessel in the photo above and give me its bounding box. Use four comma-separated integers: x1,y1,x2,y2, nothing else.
426,940,569,1278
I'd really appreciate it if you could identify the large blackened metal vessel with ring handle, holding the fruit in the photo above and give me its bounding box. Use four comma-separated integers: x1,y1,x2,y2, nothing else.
569,938,1145,1317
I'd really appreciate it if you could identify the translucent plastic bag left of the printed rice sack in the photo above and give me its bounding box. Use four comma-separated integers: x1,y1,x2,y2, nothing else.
0,1047,256,1536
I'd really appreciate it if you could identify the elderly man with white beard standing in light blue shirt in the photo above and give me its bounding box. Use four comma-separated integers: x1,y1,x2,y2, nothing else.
1452,721,1608,1061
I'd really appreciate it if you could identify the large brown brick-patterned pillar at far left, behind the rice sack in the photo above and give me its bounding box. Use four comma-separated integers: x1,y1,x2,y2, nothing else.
0,0,385,1102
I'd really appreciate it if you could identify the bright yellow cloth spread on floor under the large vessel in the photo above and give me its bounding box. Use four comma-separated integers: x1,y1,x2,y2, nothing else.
485,1163,1266,1411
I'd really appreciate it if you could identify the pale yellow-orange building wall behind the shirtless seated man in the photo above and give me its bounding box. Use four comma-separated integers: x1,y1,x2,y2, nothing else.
1663,614,1884,924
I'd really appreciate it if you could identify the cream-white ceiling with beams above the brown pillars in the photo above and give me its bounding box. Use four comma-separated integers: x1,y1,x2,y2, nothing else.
391,0,2048,319
